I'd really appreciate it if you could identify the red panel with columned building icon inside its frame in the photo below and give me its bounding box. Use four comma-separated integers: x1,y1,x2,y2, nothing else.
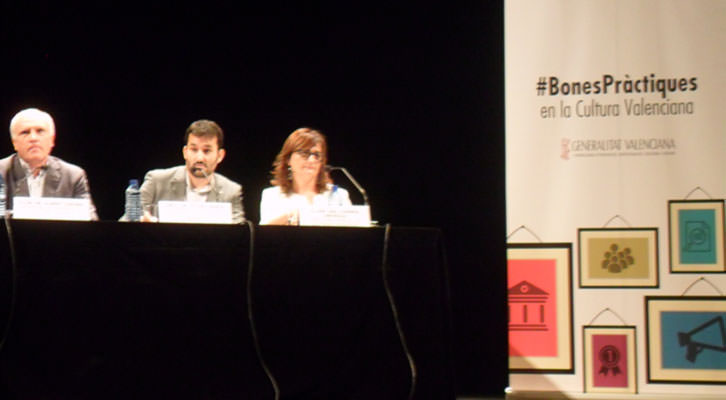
507,259,558,357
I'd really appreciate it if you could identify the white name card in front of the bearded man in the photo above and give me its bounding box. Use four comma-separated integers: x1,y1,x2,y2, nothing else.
157,200,232,224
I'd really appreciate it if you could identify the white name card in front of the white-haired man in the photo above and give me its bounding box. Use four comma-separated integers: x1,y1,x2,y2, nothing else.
13,197,91,221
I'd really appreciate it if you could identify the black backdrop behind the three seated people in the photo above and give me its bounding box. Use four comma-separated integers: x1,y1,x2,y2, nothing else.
0,1,507,395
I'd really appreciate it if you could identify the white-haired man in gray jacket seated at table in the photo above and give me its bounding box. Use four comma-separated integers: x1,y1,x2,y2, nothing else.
0,108,98,220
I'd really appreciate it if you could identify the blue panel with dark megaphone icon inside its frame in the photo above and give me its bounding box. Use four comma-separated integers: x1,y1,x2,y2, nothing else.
660,311,726,370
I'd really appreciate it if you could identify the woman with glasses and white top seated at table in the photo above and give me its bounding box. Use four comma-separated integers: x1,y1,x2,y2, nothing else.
260,128,351,225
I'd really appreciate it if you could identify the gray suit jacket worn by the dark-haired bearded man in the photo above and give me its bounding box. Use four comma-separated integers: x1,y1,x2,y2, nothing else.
141,165,245,224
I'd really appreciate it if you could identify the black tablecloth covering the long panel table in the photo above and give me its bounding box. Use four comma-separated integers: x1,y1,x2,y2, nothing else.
0,221,454,399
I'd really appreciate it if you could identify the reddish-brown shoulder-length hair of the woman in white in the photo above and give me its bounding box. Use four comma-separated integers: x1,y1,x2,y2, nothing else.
270,128,332,194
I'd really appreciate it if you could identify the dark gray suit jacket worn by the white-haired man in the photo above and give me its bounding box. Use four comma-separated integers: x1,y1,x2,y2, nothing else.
0,154,98,221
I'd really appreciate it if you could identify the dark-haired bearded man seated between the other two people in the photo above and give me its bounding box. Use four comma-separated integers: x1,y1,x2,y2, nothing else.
137,119,244,224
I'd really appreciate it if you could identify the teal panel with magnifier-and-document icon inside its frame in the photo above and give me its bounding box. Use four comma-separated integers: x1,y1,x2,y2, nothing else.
678,210,717,264
